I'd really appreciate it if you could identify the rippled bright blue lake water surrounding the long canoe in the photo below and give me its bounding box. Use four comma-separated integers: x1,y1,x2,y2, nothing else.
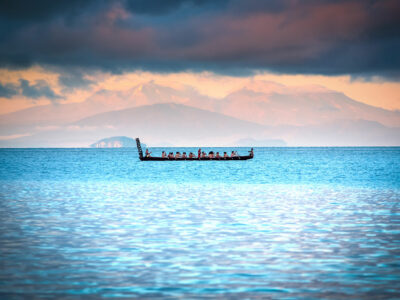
0,147,400,299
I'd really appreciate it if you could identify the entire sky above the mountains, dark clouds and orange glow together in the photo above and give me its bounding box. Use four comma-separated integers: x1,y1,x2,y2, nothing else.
0,0,400,114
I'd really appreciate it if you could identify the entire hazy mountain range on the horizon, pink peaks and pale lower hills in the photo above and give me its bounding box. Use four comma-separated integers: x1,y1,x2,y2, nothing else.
0,81,400,147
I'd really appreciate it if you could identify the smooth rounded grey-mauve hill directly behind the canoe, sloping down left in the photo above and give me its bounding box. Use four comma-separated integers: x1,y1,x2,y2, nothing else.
0,103,266,147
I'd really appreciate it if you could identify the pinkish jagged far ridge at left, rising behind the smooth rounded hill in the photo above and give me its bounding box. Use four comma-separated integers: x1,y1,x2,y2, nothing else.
0,81,206,136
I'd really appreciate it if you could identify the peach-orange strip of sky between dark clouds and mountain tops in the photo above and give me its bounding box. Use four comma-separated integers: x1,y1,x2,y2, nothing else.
0,67,400,114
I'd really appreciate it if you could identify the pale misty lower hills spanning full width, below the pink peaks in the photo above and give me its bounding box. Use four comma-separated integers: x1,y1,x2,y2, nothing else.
0,103,400,147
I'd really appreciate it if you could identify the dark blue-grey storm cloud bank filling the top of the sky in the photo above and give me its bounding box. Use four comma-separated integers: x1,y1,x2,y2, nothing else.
0,0,400,78
